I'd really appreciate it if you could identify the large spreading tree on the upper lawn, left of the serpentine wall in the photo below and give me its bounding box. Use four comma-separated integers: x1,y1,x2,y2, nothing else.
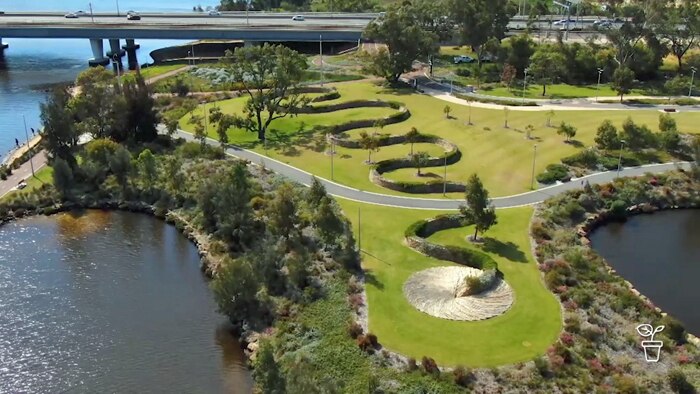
223,43,309,141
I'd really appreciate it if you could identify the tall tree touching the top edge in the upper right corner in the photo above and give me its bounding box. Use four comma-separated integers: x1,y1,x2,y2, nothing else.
655,0,700,71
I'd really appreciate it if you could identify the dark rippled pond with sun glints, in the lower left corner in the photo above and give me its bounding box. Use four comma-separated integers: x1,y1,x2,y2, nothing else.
0,211,250,393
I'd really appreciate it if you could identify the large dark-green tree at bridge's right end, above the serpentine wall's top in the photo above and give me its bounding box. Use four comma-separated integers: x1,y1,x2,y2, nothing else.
364,2,438,83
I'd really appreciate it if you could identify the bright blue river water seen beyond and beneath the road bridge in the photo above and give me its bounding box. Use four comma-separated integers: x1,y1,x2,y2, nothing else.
0,0,219,159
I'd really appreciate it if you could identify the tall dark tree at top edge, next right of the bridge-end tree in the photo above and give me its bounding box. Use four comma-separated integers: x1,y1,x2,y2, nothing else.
447,0,514,69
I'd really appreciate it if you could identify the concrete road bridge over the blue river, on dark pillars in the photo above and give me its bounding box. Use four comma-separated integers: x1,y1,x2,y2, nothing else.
0,12,377,68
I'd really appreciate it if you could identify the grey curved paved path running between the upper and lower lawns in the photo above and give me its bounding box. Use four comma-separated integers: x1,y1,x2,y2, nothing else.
174,129,690,210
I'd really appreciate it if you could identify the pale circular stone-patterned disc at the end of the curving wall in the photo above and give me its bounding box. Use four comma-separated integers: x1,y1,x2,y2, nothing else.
403,266,513,320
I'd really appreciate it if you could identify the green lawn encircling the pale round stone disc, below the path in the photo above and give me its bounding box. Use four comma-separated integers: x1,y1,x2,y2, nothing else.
339,199,561,367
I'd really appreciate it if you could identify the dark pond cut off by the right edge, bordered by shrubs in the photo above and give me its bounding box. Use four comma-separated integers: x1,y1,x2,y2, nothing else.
591,210,700,335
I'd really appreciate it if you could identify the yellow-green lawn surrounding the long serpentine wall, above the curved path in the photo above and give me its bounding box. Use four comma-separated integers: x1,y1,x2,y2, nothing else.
180,82,700,199
